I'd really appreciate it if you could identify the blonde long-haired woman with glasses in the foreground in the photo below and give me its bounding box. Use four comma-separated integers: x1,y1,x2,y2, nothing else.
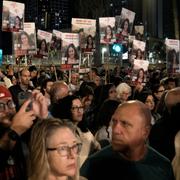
28,118,86,180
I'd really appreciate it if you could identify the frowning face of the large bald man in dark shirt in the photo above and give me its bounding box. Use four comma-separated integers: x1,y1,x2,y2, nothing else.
112,104,148,153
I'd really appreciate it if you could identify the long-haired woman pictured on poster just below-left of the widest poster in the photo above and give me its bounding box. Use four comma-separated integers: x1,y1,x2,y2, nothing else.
65,43,79,64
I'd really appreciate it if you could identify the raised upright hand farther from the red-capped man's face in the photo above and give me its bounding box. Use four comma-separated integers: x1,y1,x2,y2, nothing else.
32,90,48,119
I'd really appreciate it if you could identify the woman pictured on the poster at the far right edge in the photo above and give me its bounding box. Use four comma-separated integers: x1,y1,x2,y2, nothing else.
167,49,179,74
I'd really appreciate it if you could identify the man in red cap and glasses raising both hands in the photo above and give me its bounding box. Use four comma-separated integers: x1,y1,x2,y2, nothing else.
0,86,48,180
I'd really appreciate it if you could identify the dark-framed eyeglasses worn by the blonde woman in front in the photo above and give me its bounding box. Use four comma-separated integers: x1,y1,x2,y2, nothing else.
47,143,82,157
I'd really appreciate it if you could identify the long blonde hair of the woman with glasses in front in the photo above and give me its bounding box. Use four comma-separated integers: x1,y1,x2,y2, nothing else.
28,118,76,180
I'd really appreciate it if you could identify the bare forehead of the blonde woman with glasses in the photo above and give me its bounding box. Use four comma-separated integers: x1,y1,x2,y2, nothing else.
47,127,77,146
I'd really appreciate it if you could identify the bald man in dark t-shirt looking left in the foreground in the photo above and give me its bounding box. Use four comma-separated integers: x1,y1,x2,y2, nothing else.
81,101,174,180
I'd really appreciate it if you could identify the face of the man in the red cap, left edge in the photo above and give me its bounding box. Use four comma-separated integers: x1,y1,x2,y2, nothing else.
0,97,16,128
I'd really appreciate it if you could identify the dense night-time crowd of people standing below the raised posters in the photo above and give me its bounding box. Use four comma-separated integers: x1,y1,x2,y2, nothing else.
0,65,180,180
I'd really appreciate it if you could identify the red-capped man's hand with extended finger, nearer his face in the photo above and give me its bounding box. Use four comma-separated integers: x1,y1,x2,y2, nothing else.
10,99,36,135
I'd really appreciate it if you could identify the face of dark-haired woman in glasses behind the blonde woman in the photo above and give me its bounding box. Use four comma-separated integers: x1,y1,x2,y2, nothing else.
71,99,84,123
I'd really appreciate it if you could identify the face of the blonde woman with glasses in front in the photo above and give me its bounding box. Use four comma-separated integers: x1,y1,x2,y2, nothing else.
47,128,78,177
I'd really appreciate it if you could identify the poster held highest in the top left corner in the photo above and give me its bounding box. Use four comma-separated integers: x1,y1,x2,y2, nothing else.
2,1,25,32
